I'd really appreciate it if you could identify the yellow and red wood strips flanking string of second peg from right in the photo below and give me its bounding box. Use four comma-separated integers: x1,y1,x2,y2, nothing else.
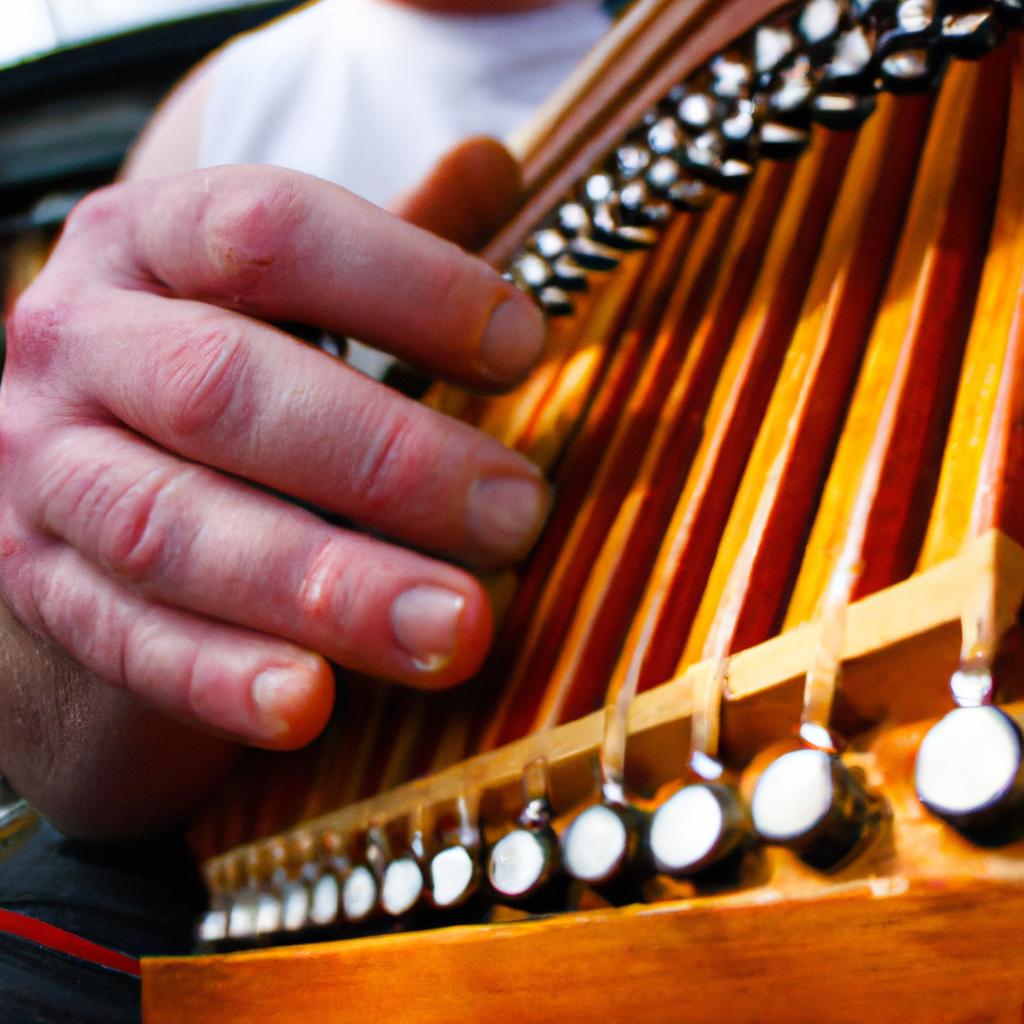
785,61,1008,625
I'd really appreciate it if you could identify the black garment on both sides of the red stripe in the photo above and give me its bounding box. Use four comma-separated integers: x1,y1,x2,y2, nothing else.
0,824,205,1024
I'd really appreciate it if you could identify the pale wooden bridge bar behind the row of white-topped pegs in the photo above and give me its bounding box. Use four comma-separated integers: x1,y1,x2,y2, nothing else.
199,530,1024,864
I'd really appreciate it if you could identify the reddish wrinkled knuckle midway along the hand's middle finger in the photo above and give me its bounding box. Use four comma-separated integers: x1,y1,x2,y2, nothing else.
153,322,251,438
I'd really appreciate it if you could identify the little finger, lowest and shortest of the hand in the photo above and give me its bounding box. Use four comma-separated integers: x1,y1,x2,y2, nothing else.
4,543,334,750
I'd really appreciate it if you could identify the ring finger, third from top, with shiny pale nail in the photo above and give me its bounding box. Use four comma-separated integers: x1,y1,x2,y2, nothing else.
17,426,490,687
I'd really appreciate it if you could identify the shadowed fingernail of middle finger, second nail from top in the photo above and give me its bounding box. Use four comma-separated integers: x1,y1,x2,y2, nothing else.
469,476,549,560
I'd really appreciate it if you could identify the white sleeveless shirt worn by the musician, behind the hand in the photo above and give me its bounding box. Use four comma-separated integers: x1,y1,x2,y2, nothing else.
200,0,609,204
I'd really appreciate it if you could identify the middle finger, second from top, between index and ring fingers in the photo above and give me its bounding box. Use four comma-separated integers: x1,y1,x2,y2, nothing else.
54,292,548,566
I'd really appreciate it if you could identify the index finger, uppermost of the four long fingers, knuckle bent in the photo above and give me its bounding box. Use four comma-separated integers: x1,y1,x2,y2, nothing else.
112,167,544,387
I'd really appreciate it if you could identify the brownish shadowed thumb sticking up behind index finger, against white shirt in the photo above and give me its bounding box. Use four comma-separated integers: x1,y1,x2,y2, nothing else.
390,135,521,250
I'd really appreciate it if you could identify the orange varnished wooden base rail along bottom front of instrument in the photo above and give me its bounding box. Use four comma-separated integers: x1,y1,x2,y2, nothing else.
142,692,1024,1024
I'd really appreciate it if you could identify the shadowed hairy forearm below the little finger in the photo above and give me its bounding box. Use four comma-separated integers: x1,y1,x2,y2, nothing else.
0,602,238,838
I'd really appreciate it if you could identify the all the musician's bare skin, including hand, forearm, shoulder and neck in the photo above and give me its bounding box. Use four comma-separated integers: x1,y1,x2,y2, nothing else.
0,0,565,836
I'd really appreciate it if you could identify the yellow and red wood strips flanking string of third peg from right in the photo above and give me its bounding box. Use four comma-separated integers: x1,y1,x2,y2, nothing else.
679,97,928,665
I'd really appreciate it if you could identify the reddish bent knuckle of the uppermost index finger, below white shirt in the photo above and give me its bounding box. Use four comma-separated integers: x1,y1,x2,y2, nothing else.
197,169,307,303
